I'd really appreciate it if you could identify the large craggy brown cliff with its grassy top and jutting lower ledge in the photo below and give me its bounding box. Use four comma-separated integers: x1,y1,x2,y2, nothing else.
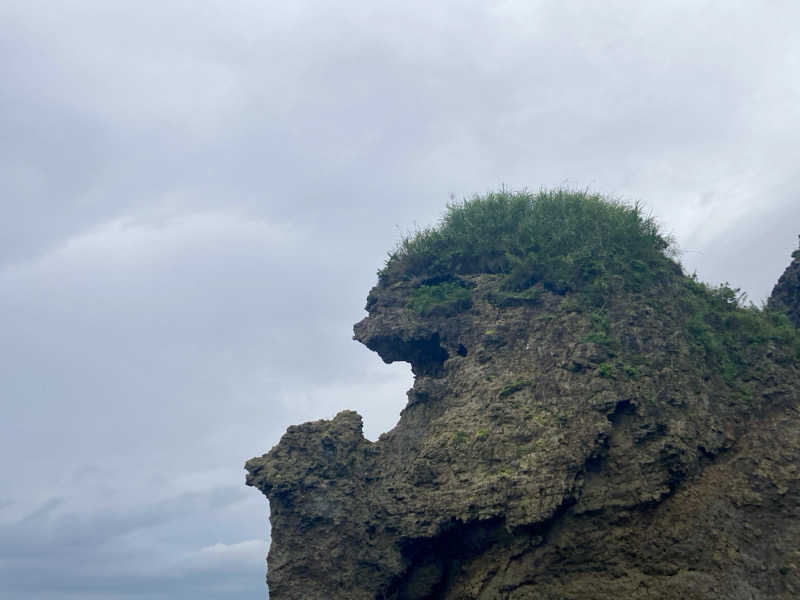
246,193,800,600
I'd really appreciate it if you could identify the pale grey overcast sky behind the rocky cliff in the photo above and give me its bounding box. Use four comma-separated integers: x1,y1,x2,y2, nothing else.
0,0,800,600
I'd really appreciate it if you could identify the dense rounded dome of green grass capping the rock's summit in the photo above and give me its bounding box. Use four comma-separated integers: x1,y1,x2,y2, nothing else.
378,190,680,302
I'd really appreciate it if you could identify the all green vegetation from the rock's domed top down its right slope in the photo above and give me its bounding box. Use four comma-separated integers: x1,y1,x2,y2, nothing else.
379,190,800,382
